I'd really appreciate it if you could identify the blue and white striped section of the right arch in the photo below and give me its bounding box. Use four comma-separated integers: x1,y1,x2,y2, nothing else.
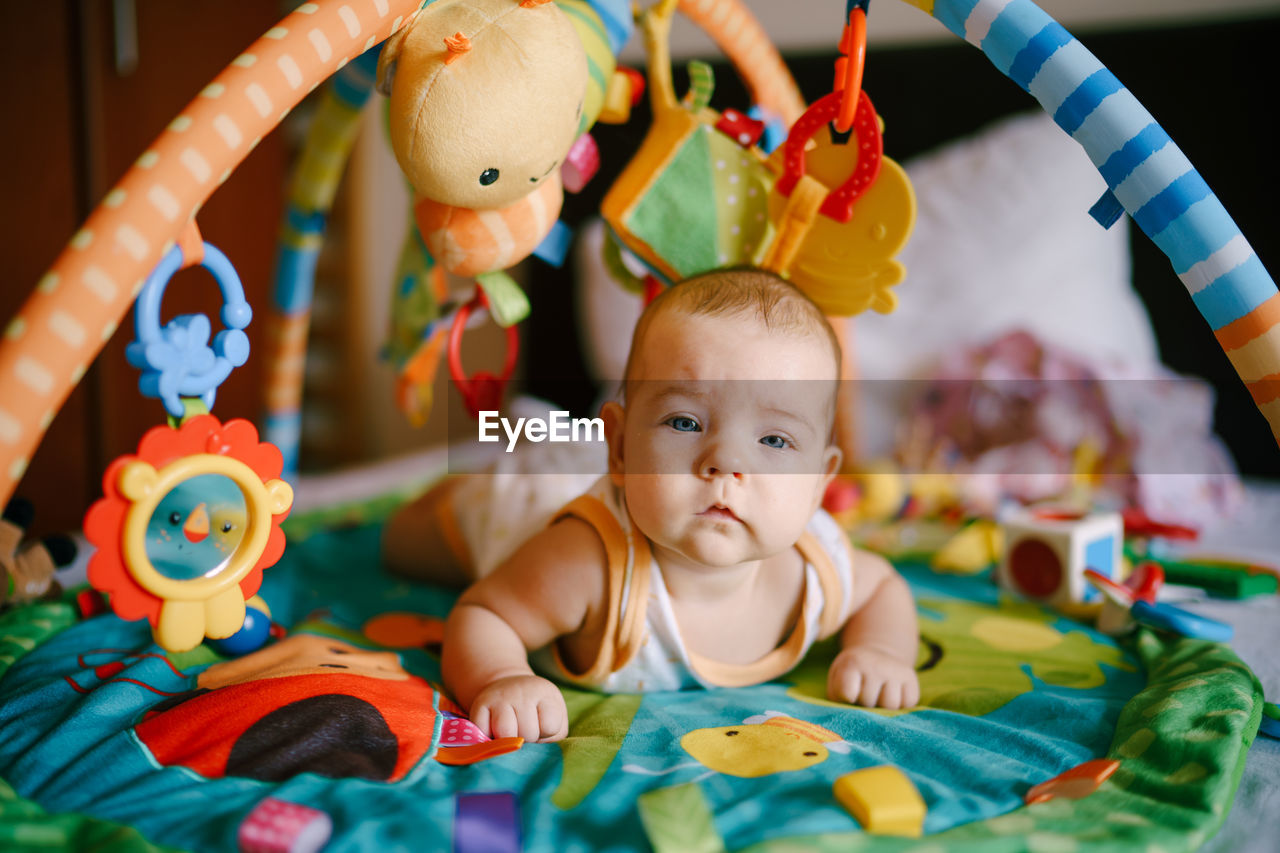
933,0,1276,329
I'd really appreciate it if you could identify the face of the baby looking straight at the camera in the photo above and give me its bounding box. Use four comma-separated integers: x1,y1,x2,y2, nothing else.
607,311,840,567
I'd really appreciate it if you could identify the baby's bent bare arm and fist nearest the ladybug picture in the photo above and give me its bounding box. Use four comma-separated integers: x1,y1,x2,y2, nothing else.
443,519,605,742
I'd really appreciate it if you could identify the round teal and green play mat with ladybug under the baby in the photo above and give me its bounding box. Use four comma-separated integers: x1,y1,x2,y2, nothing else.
0,507,1262,853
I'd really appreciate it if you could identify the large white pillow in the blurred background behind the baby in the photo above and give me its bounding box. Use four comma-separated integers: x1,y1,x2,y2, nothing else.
576,111,1158,445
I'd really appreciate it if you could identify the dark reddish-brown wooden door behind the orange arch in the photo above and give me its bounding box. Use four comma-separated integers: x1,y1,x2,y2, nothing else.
0,0,288,530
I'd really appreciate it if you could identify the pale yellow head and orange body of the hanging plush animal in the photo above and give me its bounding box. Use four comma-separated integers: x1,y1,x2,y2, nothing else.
378,0,588,275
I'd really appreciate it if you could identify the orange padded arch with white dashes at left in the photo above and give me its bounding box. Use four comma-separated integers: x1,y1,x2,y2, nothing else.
0,0,421,502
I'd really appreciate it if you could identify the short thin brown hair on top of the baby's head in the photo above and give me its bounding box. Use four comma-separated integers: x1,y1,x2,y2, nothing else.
623,266,841,379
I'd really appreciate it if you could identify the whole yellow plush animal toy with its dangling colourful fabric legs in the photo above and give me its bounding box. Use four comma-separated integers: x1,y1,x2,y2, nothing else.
378,0,632,423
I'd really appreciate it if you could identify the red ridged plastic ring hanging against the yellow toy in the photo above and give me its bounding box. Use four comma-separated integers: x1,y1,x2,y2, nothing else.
774,92,884,222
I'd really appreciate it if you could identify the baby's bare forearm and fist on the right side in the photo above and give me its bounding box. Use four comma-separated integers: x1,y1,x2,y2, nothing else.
827,549,920,708
